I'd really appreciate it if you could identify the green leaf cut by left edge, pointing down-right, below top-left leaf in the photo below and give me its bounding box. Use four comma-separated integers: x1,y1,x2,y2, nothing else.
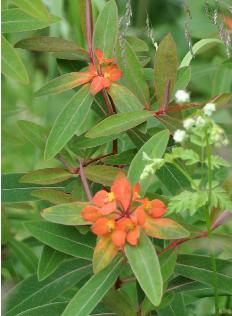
1,36,29,84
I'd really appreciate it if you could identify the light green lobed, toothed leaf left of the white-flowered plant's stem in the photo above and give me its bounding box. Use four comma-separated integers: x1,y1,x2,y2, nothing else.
168,191,208,215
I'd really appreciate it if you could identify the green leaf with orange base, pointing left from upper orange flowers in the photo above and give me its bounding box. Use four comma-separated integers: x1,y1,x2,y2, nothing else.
35,72,89,97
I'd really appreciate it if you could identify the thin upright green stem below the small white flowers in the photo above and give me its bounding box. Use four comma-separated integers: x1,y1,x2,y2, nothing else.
205,131,220,316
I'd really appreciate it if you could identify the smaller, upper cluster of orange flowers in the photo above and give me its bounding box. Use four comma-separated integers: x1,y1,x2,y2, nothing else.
79,48,122,95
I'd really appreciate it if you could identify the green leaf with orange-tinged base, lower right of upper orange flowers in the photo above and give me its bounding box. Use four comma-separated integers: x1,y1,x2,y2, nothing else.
109,83,143,113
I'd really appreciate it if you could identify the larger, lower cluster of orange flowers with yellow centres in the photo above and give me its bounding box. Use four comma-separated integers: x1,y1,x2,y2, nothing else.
81,173,167,248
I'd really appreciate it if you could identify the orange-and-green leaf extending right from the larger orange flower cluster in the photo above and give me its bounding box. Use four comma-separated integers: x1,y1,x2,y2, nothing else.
144,217,189,239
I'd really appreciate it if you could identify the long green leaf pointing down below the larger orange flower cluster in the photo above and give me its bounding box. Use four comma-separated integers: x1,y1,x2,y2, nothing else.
125,232,163,306
